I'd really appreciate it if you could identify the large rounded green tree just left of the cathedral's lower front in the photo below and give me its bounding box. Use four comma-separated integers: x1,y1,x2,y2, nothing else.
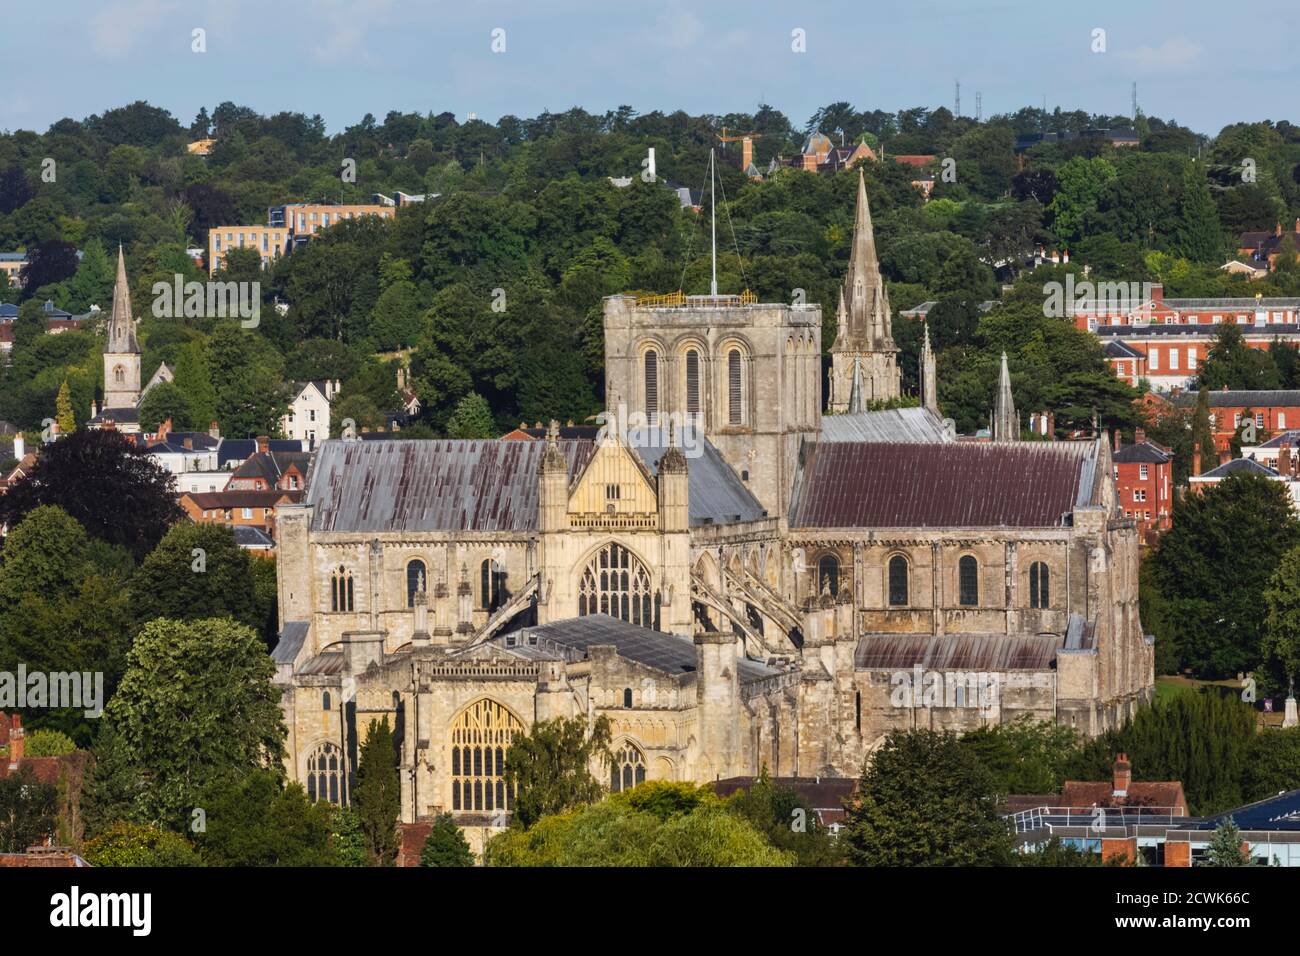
104,618,285,830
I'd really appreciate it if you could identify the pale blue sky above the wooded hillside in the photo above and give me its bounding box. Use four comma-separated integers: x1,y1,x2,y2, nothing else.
0,0,1300,134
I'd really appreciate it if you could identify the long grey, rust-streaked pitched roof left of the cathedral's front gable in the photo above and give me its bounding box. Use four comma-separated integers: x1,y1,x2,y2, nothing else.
307,440,593,532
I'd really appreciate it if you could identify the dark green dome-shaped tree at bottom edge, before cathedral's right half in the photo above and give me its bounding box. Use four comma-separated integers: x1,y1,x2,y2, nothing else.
841,731,1011,866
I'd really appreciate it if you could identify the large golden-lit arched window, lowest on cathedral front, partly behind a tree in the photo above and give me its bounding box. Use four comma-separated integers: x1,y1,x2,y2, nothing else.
451,697,524,812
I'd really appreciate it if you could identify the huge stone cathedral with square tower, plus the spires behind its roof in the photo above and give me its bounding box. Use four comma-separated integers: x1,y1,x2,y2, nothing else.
272,167,1153,843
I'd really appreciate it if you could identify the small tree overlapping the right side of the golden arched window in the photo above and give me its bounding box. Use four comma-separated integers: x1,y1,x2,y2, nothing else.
506,717,611,829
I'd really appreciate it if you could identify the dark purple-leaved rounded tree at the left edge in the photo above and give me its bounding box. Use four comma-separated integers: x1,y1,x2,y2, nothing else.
0,429,183,557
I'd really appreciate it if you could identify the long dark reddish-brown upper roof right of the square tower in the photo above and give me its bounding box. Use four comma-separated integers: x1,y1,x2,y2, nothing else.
790,441,1097,528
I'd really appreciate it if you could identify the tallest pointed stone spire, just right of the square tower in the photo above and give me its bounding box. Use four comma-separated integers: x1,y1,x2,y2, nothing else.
831,169,901,412
